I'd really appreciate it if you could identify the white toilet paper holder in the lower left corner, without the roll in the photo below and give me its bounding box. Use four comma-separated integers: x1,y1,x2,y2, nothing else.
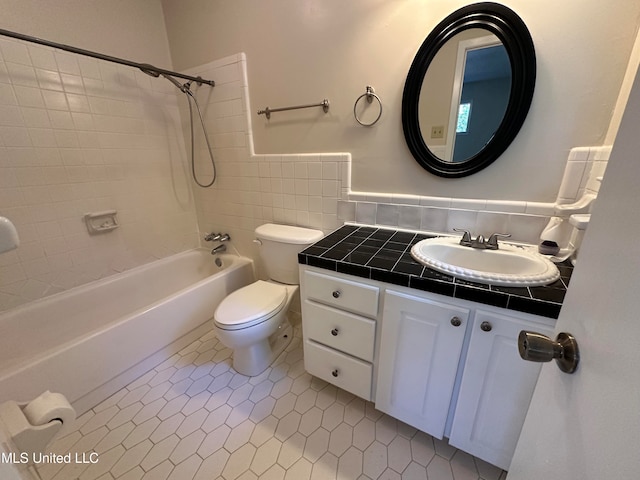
0,392,75,463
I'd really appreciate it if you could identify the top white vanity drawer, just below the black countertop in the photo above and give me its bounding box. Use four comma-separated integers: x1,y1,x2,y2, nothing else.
303,271,379,317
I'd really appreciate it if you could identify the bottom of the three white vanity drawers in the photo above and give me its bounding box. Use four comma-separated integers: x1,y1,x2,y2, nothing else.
304,340,372,400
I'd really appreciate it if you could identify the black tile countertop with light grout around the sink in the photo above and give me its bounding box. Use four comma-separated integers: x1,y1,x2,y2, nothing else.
298,225,573,318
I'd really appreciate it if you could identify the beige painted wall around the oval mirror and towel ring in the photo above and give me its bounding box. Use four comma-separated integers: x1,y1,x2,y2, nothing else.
162,0,640,202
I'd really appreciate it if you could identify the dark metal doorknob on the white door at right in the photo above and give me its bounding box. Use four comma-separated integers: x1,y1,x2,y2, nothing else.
518,330,580,373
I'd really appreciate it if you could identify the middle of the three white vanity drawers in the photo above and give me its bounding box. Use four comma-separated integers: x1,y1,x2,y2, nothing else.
302,300,376,362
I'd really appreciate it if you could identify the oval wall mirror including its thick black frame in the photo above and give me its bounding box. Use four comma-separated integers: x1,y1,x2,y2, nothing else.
402,3,536,177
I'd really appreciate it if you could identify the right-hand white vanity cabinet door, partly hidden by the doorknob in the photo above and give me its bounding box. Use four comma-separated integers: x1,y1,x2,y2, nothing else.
449,311,553,470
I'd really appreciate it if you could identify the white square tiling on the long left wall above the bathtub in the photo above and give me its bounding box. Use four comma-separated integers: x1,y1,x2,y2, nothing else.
0,40,198,311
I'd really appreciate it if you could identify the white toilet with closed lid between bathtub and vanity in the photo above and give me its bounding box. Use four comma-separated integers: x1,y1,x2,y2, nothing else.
213,223,324,377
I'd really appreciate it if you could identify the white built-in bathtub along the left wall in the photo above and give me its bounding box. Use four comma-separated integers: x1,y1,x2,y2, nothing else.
0,249,254,413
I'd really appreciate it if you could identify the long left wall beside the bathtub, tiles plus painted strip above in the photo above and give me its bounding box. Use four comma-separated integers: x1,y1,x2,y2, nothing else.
0,0,198,311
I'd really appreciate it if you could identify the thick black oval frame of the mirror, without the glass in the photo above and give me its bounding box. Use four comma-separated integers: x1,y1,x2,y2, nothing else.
402,2,536,178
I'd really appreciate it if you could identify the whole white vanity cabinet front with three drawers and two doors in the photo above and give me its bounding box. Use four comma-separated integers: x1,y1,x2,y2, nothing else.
300,266,555,469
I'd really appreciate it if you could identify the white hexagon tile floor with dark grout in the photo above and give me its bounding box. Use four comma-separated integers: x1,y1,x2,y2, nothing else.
38,328,506,480
